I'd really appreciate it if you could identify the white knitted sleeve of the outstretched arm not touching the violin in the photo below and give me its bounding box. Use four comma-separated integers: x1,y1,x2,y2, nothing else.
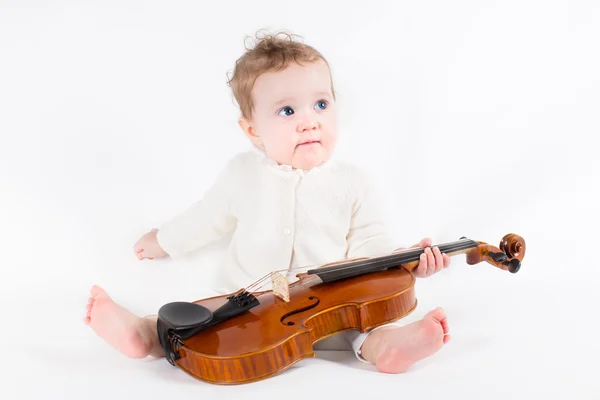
157,158,239,258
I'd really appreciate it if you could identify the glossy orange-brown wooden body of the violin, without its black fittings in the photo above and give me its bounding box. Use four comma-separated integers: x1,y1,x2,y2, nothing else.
166,268,416,383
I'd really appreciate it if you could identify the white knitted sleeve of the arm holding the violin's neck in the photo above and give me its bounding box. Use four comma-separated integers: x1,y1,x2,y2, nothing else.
346,169,399,258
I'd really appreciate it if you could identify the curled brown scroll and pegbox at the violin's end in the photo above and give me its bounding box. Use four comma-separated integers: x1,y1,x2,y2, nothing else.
467,233,526,274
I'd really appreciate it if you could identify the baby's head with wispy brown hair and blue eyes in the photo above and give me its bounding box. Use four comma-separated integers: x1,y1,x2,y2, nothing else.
229,34,338,169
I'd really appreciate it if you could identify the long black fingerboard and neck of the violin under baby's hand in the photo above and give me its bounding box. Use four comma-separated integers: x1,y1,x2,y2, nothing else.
307,238,479,282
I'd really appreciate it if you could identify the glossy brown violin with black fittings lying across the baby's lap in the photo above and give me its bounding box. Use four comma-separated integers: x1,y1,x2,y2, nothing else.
157,233,525,384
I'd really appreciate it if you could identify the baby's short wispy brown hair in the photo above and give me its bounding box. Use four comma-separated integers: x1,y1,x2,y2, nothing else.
227,31,335,119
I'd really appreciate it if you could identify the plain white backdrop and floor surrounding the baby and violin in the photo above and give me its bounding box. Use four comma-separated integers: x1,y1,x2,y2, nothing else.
0,0,600,399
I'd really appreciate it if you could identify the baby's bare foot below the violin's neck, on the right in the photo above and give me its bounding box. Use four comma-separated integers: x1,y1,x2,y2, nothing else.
362,308,450,373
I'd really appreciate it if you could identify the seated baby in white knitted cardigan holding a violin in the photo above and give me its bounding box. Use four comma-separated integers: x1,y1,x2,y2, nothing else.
84,35,450,373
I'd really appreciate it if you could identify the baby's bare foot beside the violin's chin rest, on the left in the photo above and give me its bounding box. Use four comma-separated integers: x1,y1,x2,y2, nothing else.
83,286,160,358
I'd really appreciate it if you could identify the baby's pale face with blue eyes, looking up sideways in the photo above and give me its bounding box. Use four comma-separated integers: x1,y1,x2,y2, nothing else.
244,61,338,169
